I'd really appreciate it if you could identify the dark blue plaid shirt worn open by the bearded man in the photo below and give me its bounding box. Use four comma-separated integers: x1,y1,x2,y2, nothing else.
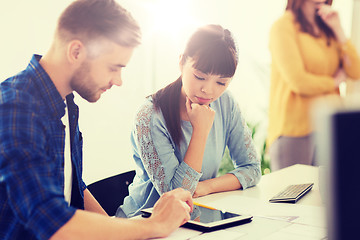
0,55,86,240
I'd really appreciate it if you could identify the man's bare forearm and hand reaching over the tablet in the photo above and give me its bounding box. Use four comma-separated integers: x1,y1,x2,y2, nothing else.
51,188,193,240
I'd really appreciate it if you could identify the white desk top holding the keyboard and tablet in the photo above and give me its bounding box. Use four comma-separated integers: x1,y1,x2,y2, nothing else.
156,165,326,240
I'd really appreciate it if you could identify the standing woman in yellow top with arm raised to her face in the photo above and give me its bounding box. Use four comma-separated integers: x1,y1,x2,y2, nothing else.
267,0,360,170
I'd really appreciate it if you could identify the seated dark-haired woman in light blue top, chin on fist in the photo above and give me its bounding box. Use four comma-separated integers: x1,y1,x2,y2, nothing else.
117,25,261,217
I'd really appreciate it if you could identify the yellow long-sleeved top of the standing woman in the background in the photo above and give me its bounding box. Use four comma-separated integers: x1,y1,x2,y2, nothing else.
267,11,360,146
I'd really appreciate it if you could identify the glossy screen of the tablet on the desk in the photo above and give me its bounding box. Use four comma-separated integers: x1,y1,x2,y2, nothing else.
190,205,241,223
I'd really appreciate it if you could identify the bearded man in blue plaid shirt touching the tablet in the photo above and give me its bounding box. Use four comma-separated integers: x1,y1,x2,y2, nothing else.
0,0,192,239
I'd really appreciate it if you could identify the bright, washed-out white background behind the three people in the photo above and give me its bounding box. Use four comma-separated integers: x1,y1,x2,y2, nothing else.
0,0,360,184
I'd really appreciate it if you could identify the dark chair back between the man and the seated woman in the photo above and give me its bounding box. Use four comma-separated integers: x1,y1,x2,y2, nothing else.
87,170,135,216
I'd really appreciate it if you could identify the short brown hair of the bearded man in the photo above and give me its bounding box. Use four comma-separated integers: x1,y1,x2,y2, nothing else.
56,0,141,47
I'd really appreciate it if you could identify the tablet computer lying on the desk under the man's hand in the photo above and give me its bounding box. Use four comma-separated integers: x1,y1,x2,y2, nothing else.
141,205,252,232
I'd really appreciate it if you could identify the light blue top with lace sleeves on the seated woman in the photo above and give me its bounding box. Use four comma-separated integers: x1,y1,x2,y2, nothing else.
117,91,261,217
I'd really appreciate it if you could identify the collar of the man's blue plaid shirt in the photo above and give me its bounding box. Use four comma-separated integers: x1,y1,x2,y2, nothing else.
27,54,66,118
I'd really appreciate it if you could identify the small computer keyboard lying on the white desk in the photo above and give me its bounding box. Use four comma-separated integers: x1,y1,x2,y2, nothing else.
269,183,314,203
